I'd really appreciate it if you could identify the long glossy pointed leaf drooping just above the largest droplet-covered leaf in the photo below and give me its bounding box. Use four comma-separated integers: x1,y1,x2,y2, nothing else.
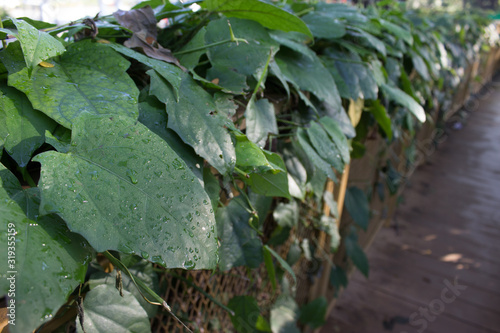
150,69,236,175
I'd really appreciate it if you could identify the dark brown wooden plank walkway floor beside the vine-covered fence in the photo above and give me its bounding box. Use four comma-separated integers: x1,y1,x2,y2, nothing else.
321,78,500,333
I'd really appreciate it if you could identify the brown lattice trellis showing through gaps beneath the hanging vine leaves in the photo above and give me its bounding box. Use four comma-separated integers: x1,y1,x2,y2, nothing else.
152,167,348,333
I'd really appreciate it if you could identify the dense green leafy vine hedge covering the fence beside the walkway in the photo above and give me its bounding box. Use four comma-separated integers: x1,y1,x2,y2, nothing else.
0,0,496,332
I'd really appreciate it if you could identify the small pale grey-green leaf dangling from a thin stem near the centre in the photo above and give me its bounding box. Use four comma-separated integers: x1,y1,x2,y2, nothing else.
245,98,278,147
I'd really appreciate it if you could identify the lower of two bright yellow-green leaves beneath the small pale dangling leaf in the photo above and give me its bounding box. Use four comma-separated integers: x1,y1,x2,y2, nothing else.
247,151,290,199
